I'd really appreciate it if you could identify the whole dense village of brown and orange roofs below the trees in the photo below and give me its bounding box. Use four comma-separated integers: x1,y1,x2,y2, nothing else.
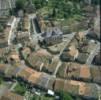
0,0,101,100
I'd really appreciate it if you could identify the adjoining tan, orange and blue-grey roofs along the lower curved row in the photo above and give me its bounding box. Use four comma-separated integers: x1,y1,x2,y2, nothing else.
16,67,55,89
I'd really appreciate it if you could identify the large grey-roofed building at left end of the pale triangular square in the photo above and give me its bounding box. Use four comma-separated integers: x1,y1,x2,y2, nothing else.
39,27,63,45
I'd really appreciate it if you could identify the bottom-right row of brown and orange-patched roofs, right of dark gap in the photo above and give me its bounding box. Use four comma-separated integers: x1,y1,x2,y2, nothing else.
54,79,99,100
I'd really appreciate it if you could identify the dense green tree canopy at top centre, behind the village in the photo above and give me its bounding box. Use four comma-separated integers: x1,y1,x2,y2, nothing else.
33,0,82,19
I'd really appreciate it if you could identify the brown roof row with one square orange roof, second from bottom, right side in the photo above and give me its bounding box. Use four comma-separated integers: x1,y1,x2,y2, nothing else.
57,62,101,84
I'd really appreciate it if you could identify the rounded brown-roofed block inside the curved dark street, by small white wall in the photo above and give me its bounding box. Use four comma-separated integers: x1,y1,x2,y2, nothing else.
26,49,52,71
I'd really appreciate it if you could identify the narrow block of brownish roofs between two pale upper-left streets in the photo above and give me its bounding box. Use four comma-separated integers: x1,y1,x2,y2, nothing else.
14,15,30,43
